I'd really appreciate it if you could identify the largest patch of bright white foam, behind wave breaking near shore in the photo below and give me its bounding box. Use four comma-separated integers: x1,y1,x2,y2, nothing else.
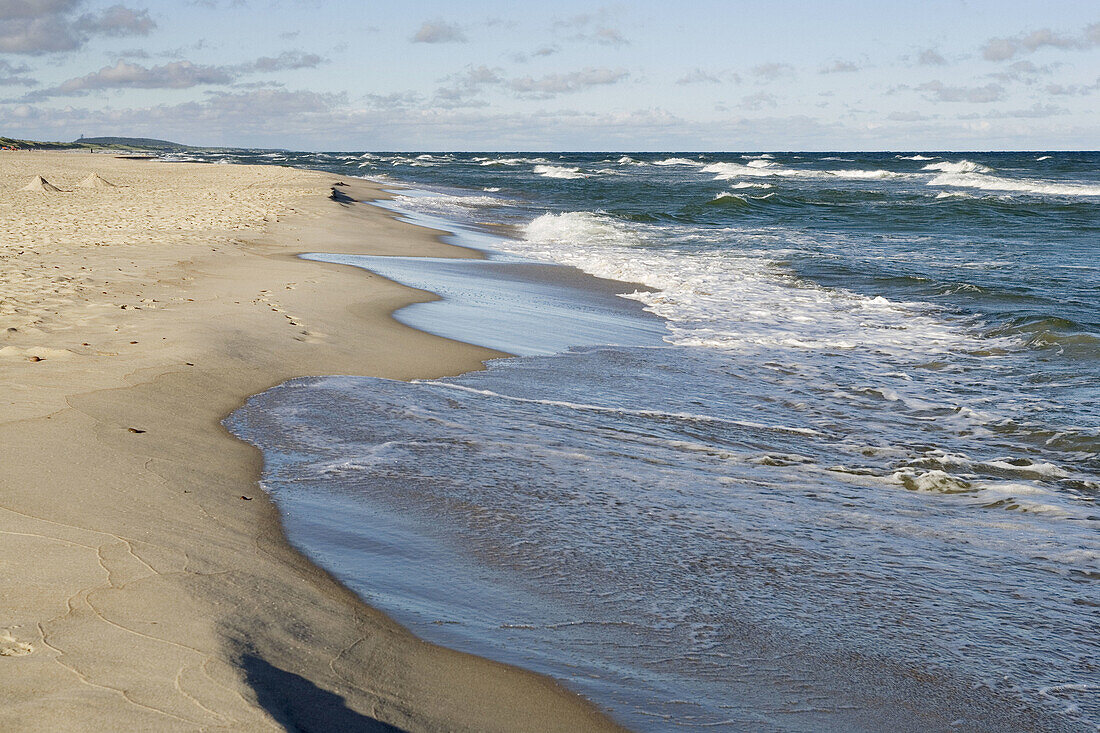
510,210,988,358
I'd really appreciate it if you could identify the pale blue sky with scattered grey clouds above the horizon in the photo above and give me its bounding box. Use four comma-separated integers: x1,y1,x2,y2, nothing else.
0,0,1100,151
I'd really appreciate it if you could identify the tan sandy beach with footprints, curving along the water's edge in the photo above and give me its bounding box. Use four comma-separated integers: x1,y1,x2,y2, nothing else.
0,152,629,731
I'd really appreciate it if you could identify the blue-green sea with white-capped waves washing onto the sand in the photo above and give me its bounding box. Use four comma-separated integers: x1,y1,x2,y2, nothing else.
204,151,1100,731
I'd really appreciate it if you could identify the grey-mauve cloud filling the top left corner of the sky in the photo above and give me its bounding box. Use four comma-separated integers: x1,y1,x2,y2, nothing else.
0,0,156,55
